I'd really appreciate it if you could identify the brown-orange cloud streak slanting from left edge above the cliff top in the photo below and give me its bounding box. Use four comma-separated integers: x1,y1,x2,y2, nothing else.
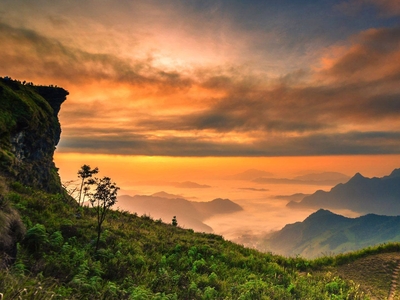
0,23,190,89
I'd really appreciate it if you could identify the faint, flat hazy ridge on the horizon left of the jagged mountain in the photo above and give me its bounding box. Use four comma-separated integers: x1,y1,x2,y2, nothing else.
252,172,350,185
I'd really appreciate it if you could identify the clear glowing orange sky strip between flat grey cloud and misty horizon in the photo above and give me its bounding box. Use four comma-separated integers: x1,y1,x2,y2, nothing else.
55,153,400,188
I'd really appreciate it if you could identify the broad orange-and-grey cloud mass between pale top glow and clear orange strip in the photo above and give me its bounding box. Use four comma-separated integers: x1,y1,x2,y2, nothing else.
0,10,400,156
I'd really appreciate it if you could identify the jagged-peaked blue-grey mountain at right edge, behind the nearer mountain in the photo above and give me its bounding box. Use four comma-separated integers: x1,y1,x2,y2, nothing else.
287,169,400,216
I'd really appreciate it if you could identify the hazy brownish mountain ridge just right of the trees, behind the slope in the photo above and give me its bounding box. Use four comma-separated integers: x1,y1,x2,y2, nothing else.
115,192,243,232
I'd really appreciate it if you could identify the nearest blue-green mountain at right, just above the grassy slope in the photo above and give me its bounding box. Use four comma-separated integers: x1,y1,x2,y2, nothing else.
258,209,400,258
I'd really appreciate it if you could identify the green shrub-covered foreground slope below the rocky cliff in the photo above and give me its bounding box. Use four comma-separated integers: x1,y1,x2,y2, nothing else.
0,183,363,299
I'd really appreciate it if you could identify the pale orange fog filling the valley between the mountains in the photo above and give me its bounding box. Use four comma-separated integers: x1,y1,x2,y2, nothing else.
120,180,356,246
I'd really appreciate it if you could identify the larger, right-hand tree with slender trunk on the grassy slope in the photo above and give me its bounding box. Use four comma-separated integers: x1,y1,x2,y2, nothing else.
89,177,119,251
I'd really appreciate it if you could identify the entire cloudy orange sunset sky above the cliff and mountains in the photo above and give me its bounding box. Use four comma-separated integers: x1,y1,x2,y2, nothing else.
0,0,400,185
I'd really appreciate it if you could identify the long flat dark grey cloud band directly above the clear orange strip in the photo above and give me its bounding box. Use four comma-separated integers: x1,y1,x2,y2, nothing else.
59,132,400,156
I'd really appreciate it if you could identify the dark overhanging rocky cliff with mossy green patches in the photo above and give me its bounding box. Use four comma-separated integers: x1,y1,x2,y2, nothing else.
0,78,68,192
